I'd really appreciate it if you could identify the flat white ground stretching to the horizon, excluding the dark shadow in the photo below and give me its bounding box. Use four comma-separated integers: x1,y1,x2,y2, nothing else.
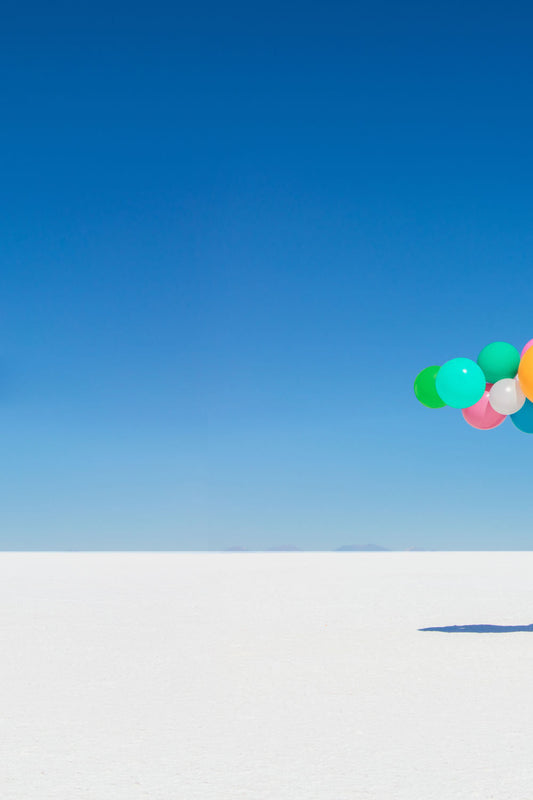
0,552,533,800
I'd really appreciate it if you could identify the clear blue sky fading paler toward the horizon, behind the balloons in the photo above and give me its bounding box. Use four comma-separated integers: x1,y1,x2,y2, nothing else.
0,0,533,550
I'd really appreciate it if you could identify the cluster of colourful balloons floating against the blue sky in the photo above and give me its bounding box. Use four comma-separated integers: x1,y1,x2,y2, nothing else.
415,339,533,433
